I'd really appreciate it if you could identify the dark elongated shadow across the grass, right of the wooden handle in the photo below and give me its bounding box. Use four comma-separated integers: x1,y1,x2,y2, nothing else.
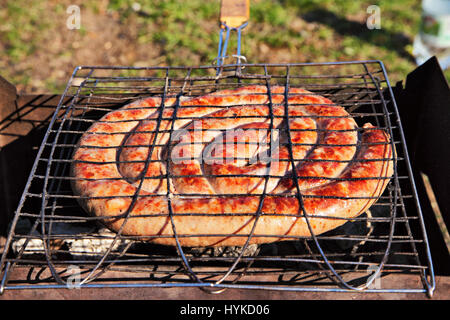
302,9,415,62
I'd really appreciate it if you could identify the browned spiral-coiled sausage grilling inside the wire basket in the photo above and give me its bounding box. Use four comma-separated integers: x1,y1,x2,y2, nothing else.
71,85,393,246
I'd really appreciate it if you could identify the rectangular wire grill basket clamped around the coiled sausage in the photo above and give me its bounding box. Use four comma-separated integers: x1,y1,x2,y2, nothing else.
1,61,434,295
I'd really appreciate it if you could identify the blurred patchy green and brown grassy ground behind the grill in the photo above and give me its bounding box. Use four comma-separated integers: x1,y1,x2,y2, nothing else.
0,0,450,93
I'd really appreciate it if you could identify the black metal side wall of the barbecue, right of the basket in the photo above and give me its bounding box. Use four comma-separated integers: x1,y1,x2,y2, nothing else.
393,57,450,275
